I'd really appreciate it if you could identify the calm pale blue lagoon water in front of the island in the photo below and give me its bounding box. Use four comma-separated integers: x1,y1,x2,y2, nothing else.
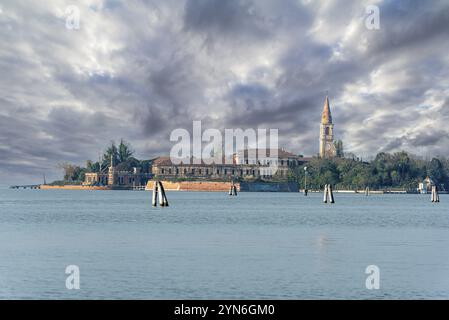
0,189,449,299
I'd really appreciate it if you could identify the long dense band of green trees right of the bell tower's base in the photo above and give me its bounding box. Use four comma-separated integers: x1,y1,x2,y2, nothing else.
289,152,449,190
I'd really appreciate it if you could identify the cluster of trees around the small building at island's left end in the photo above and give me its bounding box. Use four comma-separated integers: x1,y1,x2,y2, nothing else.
53,139,151,184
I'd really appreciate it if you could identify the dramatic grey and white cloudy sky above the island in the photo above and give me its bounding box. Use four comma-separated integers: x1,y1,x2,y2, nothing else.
0,0,449,184
